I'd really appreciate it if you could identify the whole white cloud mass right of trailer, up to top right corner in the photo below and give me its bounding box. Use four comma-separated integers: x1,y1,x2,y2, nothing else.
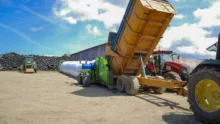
159,0,220,59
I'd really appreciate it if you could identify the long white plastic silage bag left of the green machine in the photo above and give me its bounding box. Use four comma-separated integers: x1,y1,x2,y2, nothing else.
59,60,95,77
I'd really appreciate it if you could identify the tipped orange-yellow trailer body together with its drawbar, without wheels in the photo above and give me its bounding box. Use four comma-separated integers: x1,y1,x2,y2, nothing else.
105,0,186,95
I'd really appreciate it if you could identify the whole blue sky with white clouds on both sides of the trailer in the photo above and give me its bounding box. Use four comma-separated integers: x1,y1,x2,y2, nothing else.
0,0,220,59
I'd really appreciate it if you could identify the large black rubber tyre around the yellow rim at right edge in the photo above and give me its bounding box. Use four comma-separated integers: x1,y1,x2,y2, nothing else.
188,67,220,124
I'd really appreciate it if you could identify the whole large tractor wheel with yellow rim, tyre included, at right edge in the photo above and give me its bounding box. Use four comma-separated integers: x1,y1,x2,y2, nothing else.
188,68,220,124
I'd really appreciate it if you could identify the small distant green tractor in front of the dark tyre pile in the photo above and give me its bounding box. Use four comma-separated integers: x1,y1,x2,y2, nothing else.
20,56,37,73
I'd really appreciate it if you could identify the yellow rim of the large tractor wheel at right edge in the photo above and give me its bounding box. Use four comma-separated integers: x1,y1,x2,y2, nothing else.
195,79,220,113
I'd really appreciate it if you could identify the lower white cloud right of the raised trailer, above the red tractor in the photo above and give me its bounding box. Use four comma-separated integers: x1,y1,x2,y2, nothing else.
159,23,217,57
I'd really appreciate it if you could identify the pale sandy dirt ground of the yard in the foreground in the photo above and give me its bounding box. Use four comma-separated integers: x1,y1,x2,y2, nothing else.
0,72,203,124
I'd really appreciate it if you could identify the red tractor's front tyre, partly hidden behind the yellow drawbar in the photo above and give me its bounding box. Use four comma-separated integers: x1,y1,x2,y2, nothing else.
163,71,182,92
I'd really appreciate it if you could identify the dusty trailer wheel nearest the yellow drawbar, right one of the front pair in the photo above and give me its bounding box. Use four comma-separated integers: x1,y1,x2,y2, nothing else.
125,76,140,95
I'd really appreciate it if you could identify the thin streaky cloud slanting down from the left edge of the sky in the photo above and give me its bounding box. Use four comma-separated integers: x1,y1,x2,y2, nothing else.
0,23,48,49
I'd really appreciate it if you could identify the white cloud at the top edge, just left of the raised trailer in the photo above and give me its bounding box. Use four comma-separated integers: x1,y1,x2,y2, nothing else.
53,0,125,28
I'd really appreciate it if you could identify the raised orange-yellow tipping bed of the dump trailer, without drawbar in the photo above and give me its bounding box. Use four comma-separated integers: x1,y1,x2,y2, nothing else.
108,0,176,75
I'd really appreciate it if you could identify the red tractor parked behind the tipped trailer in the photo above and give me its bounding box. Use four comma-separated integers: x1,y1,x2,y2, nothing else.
145,50,190,81
